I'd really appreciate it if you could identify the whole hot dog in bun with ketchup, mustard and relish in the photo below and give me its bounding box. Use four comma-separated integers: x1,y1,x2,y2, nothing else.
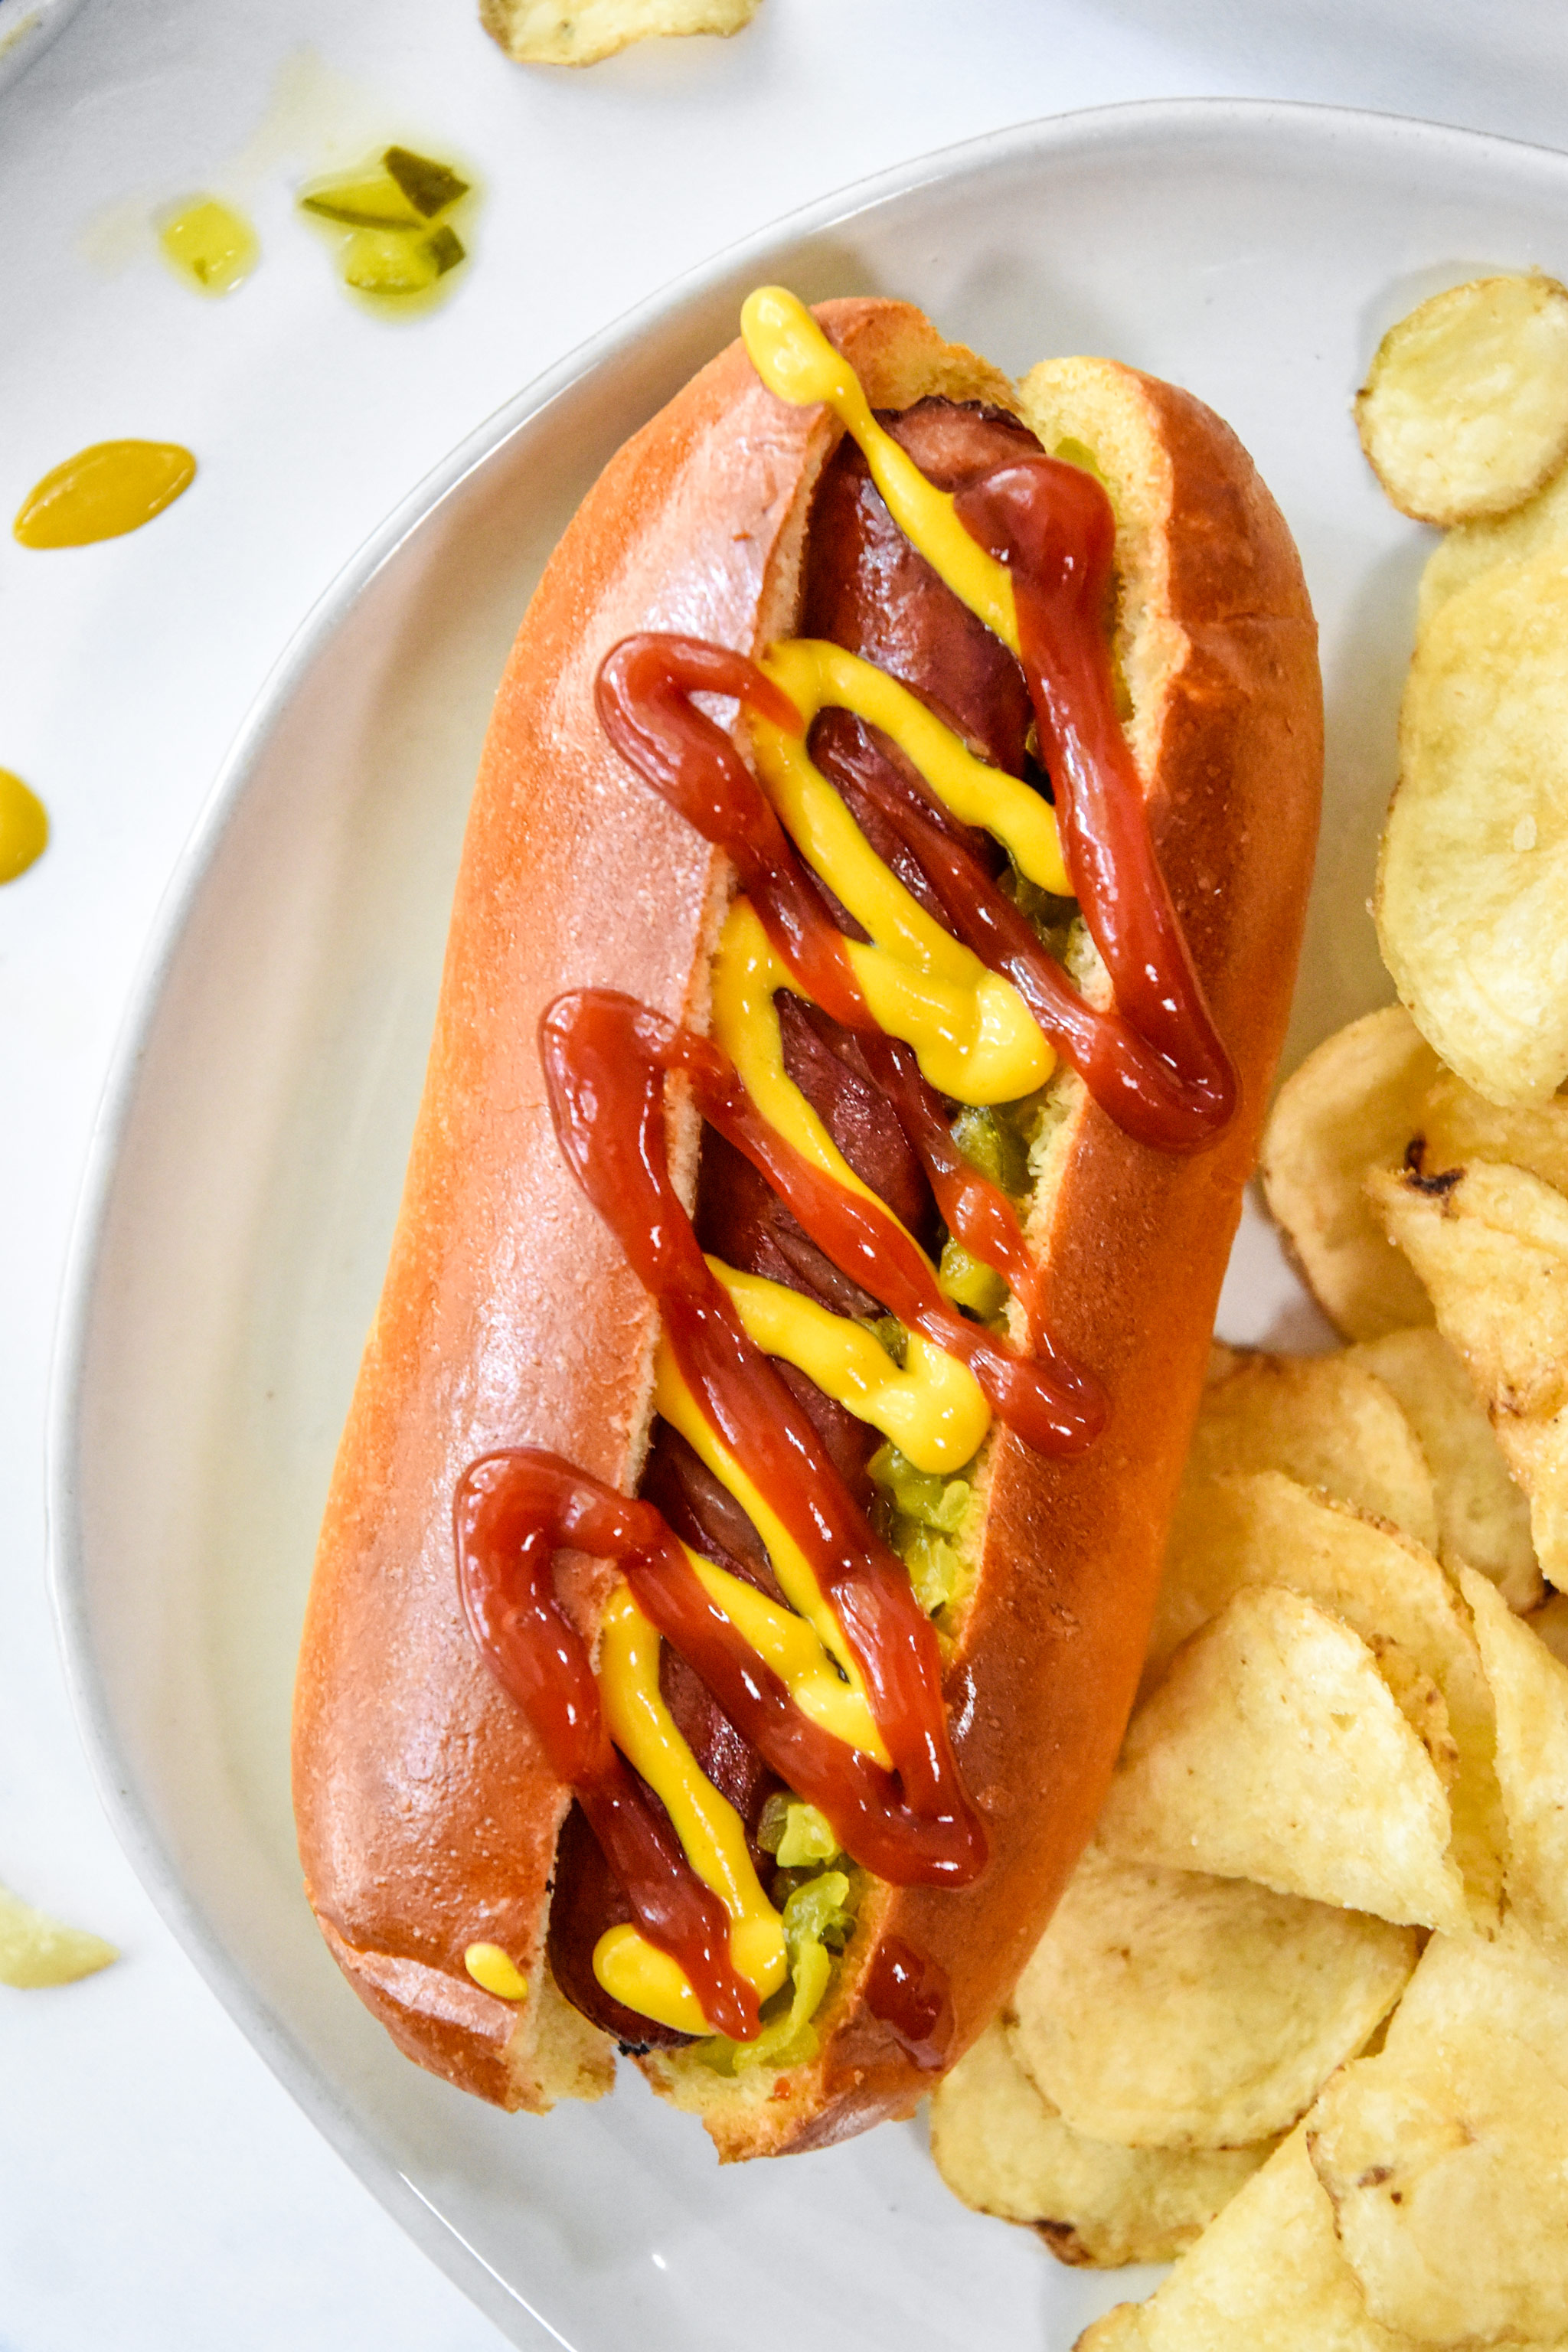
294,292,1321,2157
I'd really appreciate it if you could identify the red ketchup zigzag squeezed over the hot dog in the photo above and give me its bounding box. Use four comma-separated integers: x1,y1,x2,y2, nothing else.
456,437,1236,2067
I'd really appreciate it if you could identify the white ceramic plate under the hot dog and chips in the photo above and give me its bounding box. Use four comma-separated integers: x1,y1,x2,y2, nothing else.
52,101,1568,2352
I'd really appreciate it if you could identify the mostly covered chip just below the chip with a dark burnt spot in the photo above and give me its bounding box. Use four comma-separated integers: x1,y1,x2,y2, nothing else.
1352,1335,1542,1609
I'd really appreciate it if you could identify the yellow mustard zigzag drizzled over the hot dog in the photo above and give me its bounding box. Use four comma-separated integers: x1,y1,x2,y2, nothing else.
593,287,1072,2034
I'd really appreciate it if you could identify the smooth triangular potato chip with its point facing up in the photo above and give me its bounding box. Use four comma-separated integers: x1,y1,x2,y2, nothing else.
1100,1588,1467,1931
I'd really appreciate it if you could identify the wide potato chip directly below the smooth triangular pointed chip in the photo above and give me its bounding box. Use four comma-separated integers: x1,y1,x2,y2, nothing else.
1011,1847,1417,2148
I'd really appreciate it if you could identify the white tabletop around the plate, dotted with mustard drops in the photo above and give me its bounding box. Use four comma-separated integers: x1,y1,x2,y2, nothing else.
0,0,1568,2352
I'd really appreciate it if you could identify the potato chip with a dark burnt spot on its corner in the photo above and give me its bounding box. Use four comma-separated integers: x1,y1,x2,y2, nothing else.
1368,1159,1568,1586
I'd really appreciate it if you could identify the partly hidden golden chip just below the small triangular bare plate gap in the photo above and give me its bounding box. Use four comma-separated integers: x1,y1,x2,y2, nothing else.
1187,1354,1436,1550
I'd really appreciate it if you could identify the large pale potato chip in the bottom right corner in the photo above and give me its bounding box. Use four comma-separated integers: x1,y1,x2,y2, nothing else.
1305,1936,1568,2345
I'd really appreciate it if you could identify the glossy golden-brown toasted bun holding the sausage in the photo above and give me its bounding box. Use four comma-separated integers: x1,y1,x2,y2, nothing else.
294,301,1321,2157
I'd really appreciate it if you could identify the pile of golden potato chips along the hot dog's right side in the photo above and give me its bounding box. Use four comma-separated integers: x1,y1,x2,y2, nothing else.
931,280,1568,2352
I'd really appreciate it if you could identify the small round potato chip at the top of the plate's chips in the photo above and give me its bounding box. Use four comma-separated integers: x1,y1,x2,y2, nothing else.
1357,275,1568,524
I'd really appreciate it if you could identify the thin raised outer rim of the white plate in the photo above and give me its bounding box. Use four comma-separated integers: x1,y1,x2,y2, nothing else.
44,87,1568,2352
